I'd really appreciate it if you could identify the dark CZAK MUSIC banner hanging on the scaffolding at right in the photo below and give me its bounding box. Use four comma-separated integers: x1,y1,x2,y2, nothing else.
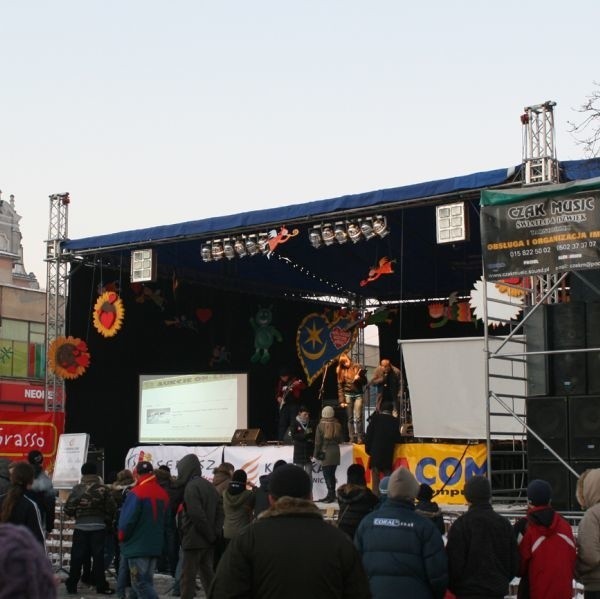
480,180,600,281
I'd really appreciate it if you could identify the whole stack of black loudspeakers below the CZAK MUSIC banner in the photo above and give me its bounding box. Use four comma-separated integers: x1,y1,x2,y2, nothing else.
525,302,600,510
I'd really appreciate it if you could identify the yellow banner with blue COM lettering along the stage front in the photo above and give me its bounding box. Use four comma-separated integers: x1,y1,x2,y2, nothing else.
353,443,487,505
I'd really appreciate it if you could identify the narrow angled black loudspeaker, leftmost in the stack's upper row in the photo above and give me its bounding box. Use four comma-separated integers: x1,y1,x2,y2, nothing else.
523,304,550,395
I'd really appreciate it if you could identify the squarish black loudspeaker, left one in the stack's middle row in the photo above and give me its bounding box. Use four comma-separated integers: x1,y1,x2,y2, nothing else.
525,397,569,460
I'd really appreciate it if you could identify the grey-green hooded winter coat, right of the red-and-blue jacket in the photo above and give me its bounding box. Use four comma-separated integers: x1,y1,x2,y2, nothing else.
176,453,223,550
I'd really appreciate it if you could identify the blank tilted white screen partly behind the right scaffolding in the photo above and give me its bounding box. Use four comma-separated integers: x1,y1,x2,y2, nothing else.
402,337,526,440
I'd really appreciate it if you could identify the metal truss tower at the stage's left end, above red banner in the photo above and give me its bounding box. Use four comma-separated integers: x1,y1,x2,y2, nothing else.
44,193,70,412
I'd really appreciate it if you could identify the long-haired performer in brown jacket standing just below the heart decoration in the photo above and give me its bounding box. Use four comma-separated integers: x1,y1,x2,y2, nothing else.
335,353,367,443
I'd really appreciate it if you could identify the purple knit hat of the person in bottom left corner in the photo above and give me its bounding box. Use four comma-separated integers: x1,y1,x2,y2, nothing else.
0,523,58,599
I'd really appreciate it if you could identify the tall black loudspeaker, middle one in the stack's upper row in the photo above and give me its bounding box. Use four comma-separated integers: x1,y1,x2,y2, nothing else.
548,302,587,395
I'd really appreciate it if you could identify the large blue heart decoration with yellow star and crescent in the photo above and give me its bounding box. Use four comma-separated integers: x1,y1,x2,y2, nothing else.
296,312,358,385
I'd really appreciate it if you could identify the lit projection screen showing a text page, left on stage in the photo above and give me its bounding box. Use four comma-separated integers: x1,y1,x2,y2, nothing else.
138,373,248,443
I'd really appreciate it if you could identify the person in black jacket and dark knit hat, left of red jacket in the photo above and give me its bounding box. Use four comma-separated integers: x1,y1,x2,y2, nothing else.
446,475,519,599
